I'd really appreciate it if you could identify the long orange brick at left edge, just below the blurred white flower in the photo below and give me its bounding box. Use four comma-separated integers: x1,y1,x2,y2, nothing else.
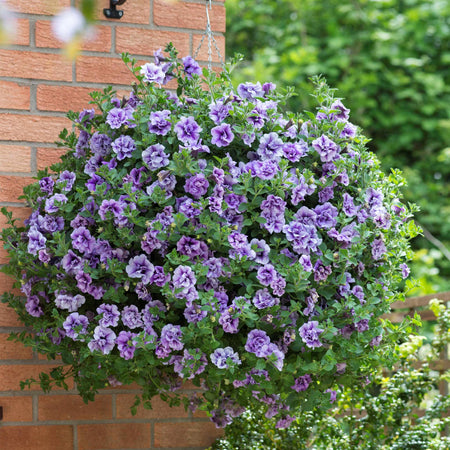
0,50,72,81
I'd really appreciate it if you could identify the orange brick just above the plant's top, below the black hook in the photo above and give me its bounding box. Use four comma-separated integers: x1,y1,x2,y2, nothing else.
116,27,190,56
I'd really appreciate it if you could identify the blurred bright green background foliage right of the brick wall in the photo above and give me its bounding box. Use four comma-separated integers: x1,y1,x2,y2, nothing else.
226,0,450,295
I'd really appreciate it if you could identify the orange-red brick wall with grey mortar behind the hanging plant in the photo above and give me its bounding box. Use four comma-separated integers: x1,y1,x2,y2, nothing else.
0,0,225,450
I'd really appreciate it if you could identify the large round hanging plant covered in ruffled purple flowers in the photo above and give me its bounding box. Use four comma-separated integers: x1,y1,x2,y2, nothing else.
2,46,417,427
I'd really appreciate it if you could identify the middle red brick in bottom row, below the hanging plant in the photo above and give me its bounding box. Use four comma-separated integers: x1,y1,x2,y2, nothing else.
78,423,150,450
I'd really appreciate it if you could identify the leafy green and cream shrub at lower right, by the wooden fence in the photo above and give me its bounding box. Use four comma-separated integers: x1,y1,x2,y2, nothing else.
211,300,450,450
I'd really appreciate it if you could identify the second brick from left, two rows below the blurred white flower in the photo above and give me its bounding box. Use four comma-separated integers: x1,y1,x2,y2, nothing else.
36,84,94,112
